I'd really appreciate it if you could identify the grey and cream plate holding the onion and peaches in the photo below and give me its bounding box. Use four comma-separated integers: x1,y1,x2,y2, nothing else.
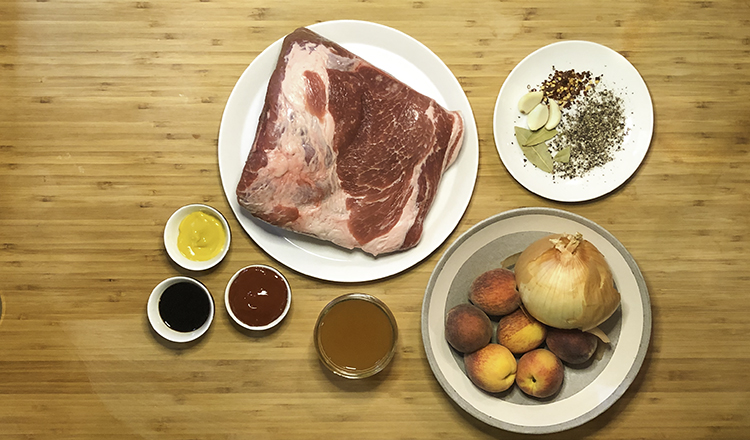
422,208,651,434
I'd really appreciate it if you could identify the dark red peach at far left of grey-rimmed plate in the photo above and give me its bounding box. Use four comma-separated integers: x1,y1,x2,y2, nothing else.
445,304,492,353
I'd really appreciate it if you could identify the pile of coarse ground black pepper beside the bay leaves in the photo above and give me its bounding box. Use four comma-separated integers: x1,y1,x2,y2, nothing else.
550,89,626,179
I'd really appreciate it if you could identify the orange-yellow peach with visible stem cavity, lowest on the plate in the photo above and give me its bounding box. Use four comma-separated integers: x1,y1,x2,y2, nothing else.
516,348,565,399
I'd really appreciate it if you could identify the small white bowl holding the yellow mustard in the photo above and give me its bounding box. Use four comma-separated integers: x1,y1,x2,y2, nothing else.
164,204,232,272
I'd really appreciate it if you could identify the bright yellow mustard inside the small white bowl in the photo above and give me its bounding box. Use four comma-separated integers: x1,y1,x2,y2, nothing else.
177,211,227,261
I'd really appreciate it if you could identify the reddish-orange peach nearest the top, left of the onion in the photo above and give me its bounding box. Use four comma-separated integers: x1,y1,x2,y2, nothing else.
469,267,521,316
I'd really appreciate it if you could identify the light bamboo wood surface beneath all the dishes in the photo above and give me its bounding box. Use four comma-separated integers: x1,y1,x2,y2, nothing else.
0,0,750,439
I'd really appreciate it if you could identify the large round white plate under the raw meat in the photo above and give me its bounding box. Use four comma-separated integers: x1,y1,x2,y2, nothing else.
218,20,479,282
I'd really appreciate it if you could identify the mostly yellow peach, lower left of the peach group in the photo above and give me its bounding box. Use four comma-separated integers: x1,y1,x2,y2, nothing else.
464,343,516,393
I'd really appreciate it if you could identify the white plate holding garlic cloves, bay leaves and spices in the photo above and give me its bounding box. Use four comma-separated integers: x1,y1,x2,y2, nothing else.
493,41,654,202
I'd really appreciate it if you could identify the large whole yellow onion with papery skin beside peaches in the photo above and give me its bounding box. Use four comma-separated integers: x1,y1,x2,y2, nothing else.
515,233,620,331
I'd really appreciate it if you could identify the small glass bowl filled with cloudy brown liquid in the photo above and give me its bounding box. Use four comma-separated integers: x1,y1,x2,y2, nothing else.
318,299,395,374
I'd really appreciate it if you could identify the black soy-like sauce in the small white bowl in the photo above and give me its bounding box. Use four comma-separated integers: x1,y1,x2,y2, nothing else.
159,281,211,332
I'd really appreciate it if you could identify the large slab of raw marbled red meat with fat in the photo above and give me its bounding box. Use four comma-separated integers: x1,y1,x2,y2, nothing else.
237,28,464,255
